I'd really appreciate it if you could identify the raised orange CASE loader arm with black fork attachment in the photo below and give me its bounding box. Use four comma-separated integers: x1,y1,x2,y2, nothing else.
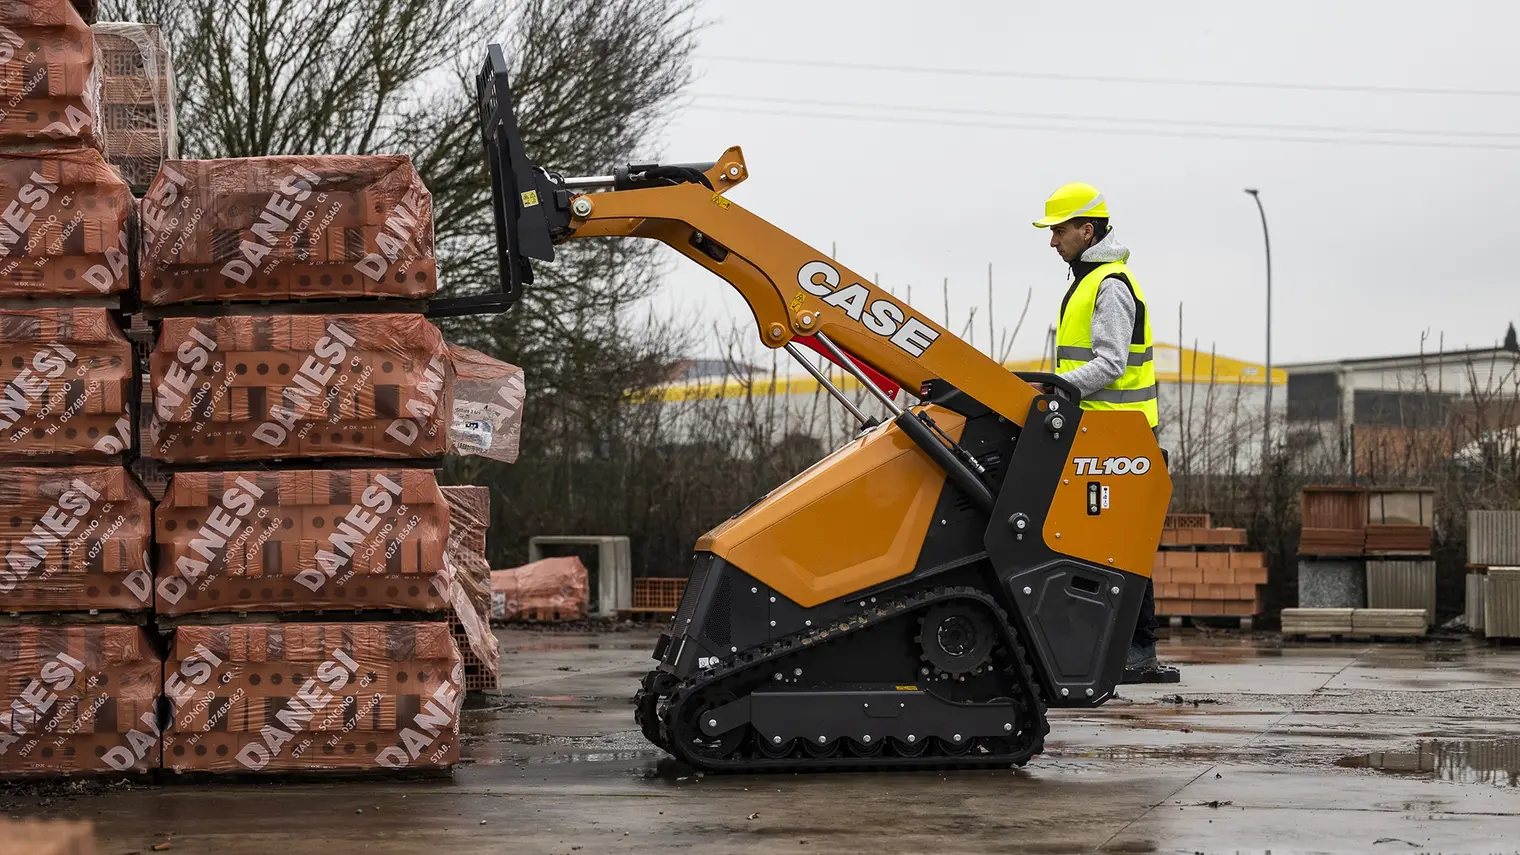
479,46,1051,426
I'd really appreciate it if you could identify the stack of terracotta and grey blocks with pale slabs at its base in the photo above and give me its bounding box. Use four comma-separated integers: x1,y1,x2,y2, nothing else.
1283,485,1436,636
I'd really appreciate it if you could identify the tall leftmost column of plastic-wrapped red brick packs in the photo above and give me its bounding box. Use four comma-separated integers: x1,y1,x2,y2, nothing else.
0,0,161,777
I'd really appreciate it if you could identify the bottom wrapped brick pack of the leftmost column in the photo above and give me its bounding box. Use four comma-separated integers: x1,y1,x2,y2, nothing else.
0,625,163,777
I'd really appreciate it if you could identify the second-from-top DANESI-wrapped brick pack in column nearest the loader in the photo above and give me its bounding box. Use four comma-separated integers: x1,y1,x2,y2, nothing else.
143,315,453,462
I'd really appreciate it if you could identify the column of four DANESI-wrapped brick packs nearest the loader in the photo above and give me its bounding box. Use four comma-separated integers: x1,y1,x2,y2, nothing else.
138,157,509,773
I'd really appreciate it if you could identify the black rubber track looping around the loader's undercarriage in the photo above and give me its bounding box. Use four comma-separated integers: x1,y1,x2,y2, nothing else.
653,587,1050,773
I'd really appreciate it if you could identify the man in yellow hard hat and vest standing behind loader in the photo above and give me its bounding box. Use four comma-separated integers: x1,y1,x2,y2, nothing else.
1034,184,1161,677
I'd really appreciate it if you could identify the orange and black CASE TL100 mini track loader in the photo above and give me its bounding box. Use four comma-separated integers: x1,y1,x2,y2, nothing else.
479,46,1172,771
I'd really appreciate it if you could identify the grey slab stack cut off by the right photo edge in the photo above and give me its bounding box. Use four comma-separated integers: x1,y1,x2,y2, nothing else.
1467,510,1520,639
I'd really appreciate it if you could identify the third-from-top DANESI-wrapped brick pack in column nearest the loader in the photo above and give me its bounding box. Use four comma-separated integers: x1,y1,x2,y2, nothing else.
155,469,453,615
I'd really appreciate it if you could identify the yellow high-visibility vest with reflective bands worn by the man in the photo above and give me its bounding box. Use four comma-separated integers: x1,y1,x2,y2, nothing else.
1055,262,1161,428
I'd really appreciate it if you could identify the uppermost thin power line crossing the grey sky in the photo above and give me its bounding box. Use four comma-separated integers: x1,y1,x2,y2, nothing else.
699,55,1520,97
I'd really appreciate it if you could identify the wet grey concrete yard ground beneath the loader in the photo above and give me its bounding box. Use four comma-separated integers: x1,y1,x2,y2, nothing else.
3,631,1520,855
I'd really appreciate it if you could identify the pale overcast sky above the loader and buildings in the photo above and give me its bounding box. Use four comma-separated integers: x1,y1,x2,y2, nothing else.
641,0,1520,364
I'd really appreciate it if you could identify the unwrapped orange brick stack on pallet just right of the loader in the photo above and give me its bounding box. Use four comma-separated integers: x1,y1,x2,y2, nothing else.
1151,514,1266,628
